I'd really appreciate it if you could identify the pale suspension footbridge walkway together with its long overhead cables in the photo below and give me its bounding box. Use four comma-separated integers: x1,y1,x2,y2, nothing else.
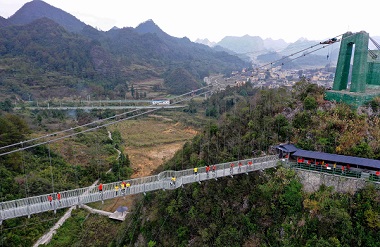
0,30,378,224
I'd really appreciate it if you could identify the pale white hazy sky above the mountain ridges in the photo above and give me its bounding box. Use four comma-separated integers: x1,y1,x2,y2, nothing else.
0,0,380,42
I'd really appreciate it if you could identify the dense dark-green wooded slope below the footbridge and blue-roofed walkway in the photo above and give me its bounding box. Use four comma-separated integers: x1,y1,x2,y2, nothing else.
122,168,380,246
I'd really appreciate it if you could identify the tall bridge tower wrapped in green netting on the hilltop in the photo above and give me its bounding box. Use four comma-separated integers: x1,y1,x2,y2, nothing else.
325,31,380,107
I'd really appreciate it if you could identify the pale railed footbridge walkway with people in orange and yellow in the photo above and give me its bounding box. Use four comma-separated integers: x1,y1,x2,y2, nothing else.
0,155,278,224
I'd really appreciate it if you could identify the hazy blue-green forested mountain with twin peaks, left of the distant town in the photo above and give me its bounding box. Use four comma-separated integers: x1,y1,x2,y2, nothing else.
0,1,249,100
